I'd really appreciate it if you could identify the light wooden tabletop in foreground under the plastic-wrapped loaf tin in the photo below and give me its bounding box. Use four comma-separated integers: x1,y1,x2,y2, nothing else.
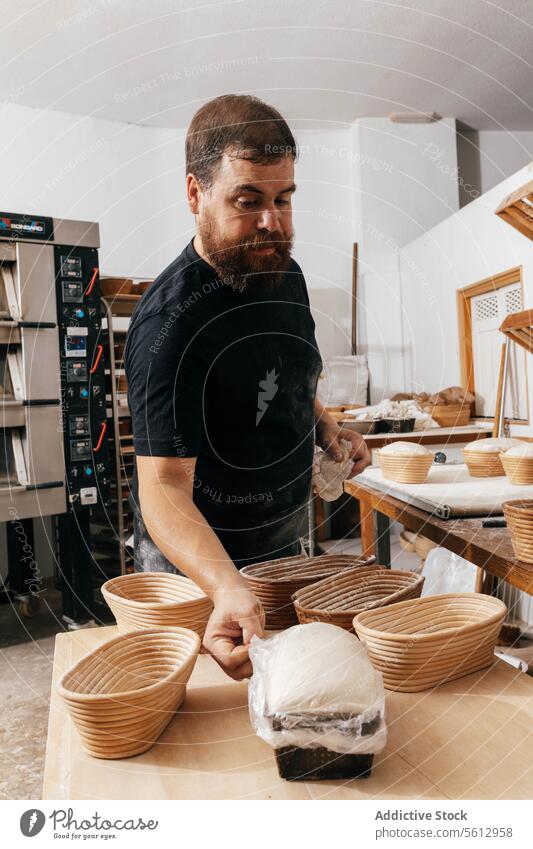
43,627,533,800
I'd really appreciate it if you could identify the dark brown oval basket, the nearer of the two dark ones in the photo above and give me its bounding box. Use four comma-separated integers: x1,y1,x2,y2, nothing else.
292,566,424,631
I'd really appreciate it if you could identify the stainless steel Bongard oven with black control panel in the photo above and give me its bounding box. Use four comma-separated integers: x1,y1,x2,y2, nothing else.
0,213,105,521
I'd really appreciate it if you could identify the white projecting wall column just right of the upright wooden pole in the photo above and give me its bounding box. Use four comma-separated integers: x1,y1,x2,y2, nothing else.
353,118,459,403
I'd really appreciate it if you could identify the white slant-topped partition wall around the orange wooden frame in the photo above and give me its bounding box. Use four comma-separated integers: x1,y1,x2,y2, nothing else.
400,163,533,435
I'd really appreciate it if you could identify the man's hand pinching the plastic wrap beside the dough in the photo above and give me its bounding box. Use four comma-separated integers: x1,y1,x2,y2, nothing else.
204,578,265,681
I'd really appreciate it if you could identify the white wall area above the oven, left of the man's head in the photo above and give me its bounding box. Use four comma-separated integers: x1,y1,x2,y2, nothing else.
0,105,188,277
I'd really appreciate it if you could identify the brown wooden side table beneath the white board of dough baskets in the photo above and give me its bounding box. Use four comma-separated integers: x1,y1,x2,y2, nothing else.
344,479,533,595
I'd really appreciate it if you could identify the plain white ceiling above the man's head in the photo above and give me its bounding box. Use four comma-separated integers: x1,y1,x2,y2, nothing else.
0,0,533,130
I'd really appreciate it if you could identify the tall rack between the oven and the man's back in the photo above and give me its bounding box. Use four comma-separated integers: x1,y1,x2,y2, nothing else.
91,277,152,580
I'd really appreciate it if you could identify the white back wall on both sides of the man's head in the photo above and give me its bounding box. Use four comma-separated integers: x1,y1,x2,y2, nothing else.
0,104,354,356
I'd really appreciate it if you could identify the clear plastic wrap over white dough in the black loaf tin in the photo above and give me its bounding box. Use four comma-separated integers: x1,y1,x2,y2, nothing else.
248,622,387,754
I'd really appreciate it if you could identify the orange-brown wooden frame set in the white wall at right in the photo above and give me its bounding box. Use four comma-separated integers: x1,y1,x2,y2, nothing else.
457,265,530,426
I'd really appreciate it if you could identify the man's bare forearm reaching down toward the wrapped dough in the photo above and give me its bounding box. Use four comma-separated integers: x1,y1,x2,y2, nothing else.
139,480,244,598
